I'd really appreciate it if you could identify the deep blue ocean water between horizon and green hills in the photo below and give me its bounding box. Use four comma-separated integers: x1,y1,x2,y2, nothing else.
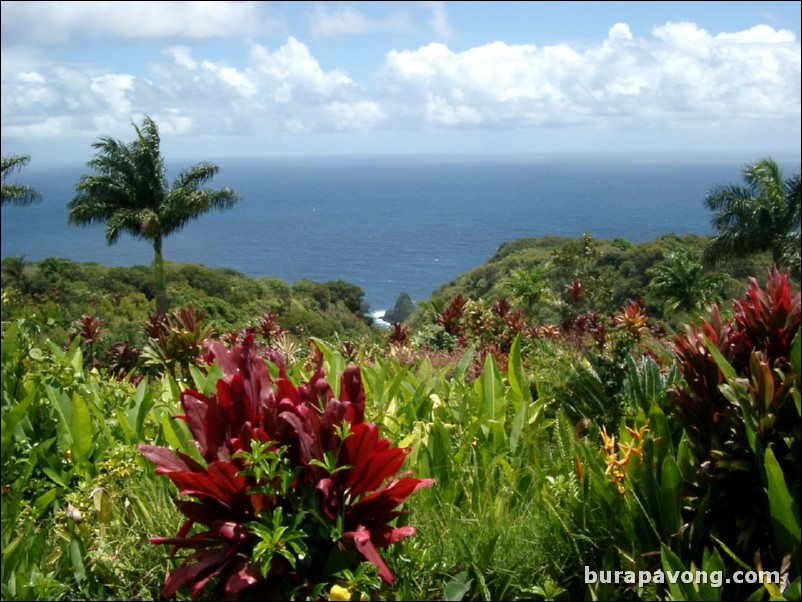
1,155,799,311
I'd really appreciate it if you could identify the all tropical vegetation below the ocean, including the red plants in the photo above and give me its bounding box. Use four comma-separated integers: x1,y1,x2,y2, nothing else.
0,151,802,600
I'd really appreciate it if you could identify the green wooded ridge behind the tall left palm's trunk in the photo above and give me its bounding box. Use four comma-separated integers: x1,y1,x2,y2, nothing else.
2,258,379,350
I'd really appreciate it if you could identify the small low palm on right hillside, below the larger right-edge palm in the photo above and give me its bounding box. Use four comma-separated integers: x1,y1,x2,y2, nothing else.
646,249,727,312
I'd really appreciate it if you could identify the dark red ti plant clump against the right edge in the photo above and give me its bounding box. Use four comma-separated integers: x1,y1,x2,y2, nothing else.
669,268,802,567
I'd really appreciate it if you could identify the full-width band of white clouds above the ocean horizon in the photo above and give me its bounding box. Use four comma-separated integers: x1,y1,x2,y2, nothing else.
0,21,802,152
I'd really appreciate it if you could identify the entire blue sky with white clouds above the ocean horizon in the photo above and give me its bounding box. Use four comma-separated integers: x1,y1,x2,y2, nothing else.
0,1,802,163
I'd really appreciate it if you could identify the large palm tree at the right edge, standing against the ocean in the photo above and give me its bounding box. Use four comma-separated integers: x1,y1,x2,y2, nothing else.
704,158,802,266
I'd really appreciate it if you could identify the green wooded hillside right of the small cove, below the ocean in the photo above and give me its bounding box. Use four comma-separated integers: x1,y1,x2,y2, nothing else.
412,234,772,323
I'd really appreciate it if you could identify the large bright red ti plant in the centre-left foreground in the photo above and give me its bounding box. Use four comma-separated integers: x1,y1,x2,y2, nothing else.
139,333,433,599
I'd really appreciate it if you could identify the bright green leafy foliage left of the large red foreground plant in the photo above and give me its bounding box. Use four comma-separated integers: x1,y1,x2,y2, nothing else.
2,320,184,600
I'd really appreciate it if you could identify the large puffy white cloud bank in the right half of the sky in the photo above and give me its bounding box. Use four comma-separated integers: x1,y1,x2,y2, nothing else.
382,23,800,127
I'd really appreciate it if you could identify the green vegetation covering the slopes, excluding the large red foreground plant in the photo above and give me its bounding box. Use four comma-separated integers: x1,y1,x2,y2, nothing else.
2,220,802,600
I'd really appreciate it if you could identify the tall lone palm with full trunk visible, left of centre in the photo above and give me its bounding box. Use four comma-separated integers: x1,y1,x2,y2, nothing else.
68,116,240,315
